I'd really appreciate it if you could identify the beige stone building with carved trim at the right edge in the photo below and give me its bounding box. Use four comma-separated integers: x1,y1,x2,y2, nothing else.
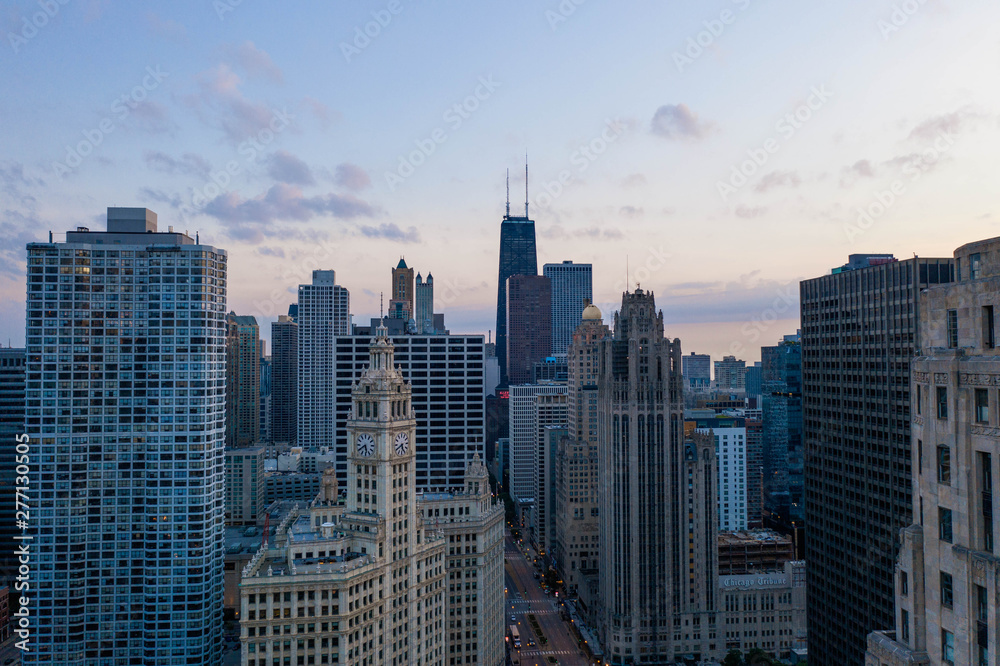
866,238,1000,666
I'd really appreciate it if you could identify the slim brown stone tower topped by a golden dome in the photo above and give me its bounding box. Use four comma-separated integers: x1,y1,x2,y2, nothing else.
552,305,611,596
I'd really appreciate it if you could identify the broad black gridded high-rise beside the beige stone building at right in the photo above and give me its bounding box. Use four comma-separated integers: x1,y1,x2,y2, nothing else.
799,250,955,666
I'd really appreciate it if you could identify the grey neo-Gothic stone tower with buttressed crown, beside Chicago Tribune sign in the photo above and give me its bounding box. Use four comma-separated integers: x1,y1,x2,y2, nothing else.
598,288,725,664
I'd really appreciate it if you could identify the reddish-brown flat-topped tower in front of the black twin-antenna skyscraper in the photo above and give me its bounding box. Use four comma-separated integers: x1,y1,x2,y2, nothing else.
507,275,552,384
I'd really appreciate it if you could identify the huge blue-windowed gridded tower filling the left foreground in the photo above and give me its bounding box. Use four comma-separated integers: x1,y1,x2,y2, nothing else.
24,208,227,666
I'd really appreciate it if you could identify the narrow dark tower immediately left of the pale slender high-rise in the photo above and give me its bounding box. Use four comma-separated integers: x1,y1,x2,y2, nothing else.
271,315,299,442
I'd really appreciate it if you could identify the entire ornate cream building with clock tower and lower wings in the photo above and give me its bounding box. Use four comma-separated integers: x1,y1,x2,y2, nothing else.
239,327,503,666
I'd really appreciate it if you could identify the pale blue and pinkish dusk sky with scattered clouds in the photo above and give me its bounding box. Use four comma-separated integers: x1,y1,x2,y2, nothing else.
0,0,1000,361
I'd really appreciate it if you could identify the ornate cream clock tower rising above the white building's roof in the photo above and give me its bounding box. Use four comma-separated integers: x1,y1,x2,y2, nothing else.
345,325,418,560
